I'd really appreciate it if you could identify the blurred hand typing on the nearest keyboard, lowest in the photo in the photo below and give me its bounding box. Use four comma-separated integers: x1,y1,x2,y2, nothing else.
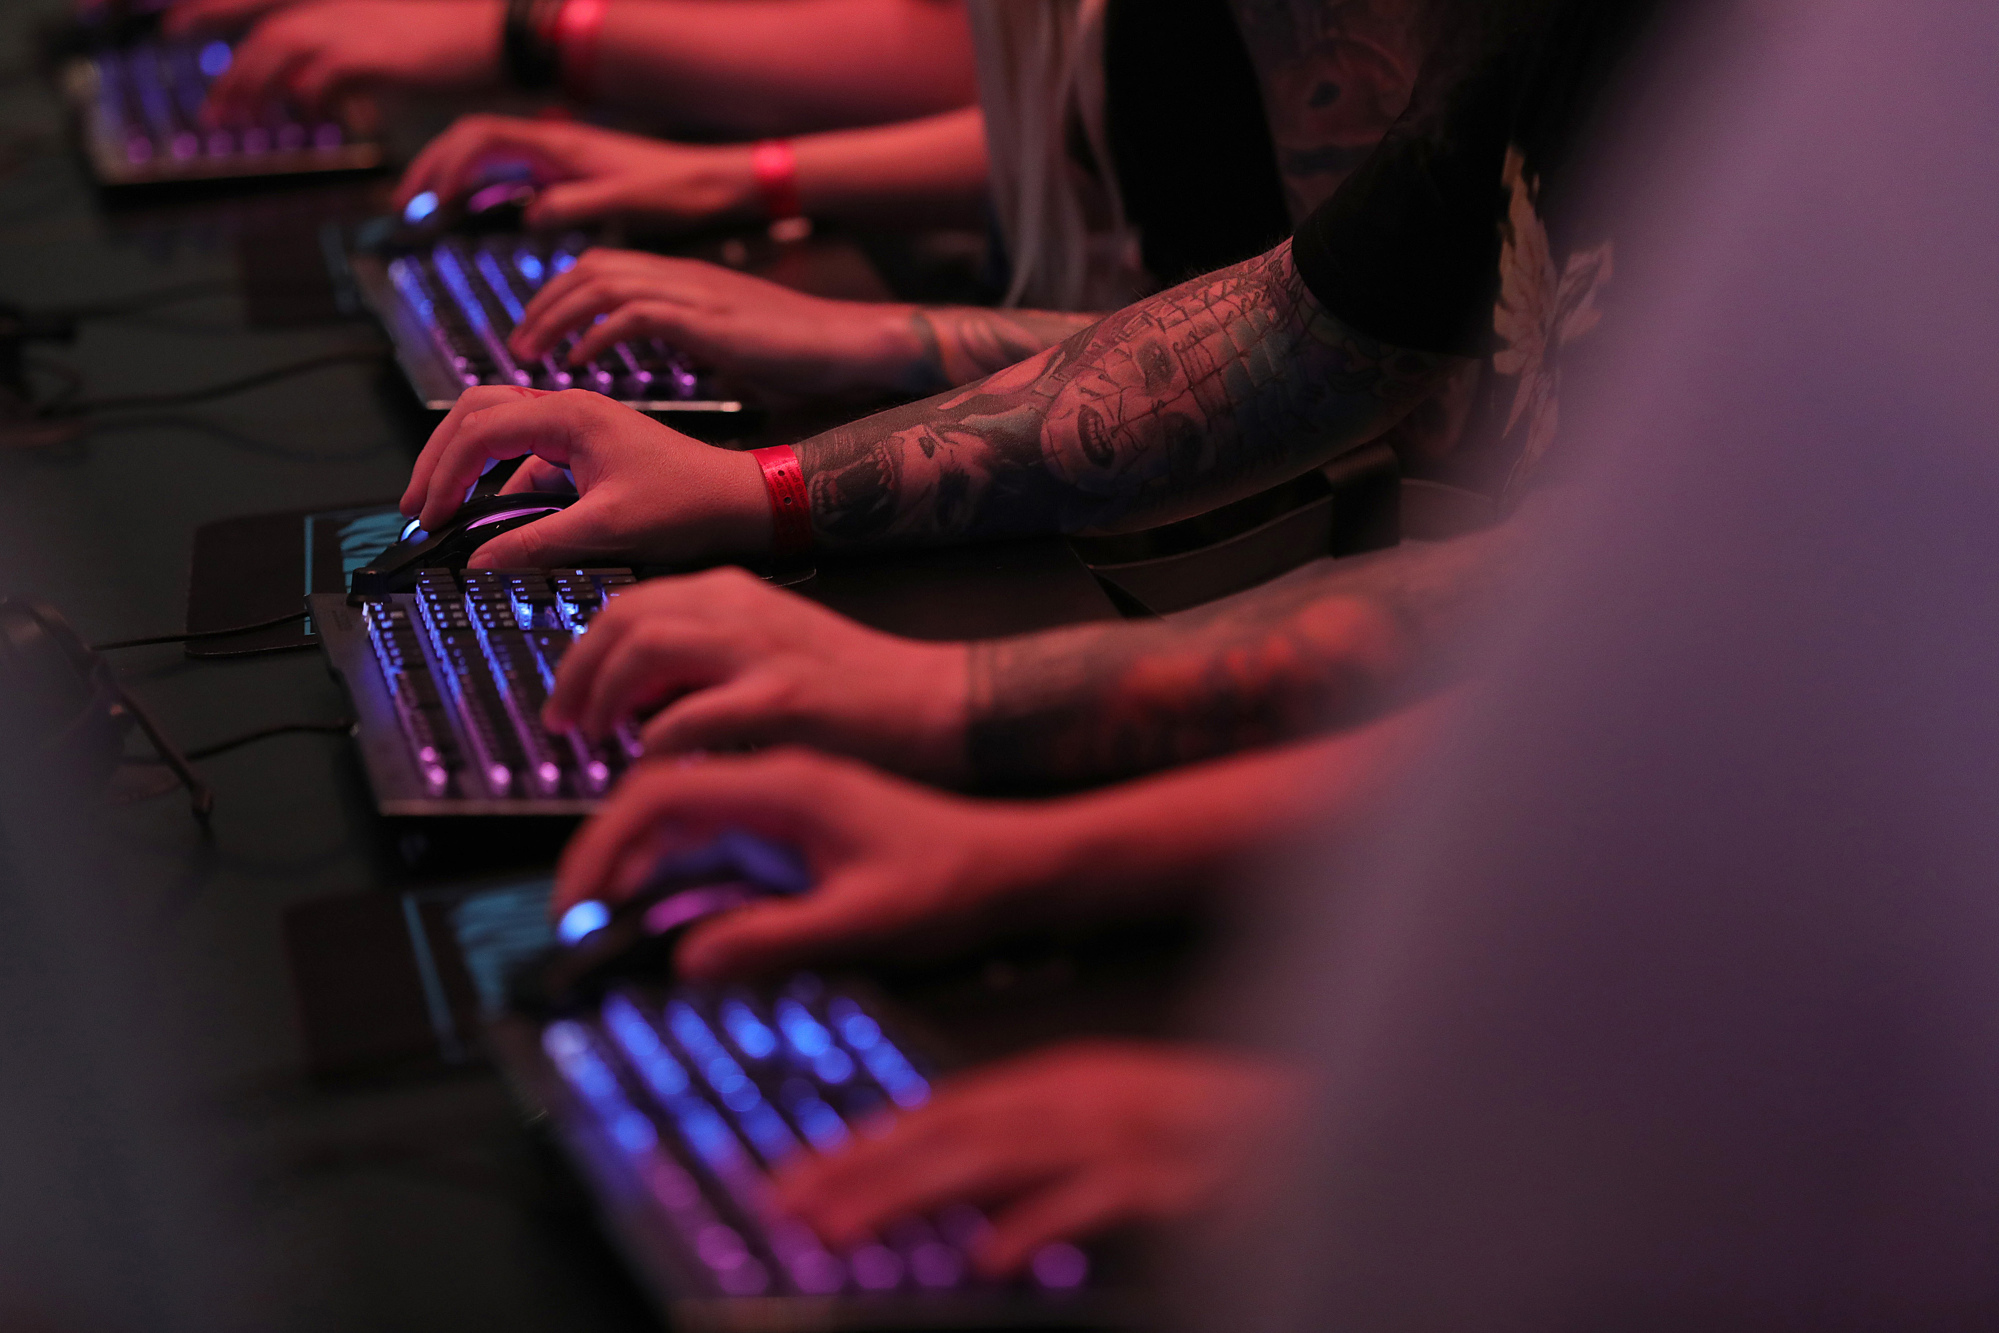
778,1041,1297,1277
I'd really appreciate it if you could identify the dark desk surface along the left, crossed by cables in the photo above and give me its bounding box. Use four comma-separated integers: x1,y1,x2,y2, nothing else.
0,0,1199,1333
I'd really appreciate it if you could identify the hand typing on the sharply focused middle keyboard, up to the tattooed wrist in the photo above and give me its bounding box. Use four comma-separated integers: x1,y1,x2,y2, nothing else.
546,570,966,781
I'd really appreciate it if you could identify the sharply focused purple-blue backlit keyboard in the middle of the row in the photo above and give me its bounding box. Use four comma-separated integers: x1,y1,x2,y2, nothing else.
310,570,640,815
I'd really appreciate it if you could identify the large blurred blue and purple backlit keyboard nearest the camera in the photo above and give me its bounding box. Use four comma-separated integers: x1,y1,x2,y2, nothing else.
479,975,1119,1333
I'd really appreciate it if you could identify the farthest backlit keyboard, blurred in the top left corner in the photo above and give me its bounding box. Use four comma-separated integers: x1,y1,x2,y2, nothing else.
68,40,382,186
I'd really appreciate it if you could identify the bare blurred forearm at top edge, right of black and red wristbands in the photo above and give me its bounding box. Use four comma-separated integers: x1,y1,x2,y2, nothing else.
592,0,978,138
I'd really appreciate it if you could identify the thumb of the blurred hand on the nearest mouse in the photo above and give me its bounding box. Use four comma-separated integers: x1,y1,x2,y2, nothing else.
674,875,888,981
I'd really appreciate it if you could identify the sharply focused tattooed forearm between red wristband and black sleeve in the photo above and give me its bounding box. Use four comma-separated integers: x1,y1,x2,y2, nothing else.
798,242,1447,546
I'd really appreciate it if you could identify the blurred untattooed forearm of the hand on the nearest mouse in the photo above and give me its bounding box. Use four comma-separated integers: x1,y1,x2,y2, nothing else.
999,695,1451,925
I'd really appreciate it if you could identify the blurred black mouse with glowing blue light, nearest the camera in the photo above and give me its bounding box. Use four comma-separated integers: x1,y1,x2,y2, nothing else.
508,831,812,1017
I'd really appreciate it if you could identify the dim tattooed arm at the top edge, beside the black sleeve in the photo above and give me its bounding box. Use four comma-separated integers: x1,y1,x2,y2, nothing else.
1233,0,1425,222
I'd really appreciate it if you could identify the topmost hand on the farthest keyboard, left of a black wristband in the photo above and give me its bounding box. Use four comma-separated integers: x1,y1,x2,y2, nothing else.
202,0,502,126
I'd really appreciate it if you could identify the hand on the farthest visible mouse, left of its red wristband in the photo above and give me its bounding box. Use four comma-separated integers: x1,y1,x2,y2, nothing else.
396,115,762,230
